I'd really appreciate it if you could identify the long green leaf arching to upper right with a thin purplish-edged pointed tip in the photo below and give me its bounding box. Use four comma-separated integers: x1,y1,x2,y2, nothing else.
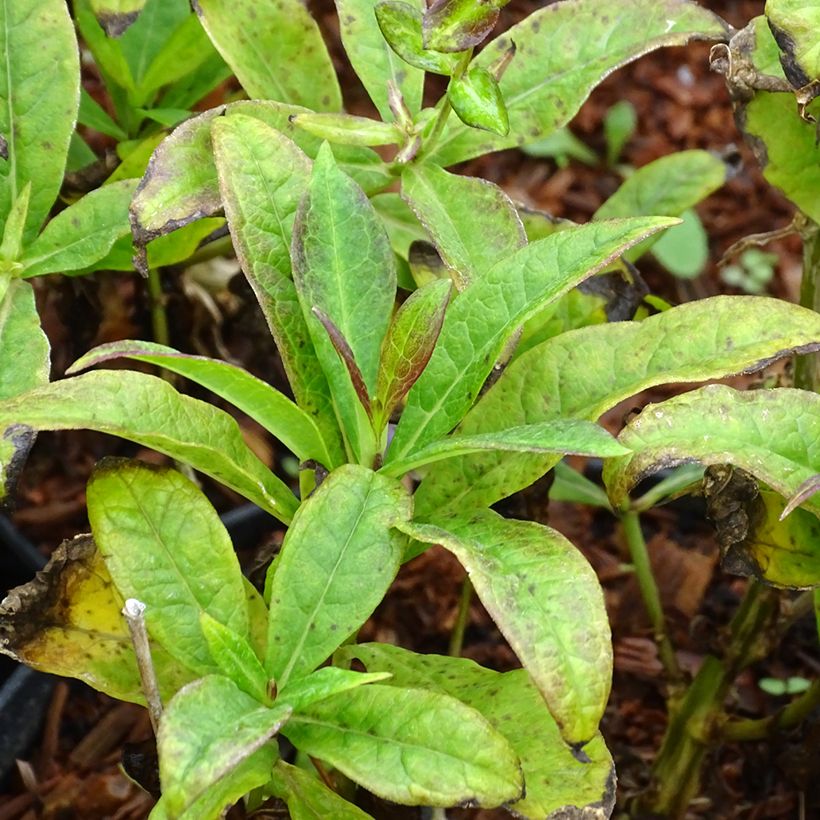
386,218,670,463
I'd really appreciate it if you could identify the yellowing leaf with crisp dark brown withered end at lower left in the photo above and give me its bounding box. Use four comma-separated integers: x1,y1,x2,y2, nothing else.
0,535,195,703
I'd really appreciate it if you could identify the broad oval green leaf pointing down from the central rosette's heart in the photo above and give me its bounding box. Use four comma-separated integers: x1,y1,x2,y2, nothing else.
265,464,411,688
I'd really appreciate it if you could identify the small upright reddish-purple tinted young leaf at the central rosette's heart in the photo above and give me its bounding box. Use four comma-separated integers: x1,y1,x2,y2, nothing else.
373,280,452,430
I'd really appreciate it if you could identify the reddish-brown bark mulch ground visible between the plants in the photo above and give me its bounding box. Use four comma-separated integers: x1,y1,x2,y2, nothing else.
0,0,820,820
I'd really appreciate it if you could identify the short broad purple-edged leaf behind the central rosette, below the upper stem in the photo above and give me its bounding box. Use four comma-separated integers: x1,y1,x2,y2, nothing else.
402,165,526,290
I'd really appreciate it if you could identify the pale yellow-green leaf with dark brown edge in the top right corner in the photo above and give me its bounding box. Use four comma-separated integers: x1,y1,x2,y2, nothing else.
766,0,820,81
